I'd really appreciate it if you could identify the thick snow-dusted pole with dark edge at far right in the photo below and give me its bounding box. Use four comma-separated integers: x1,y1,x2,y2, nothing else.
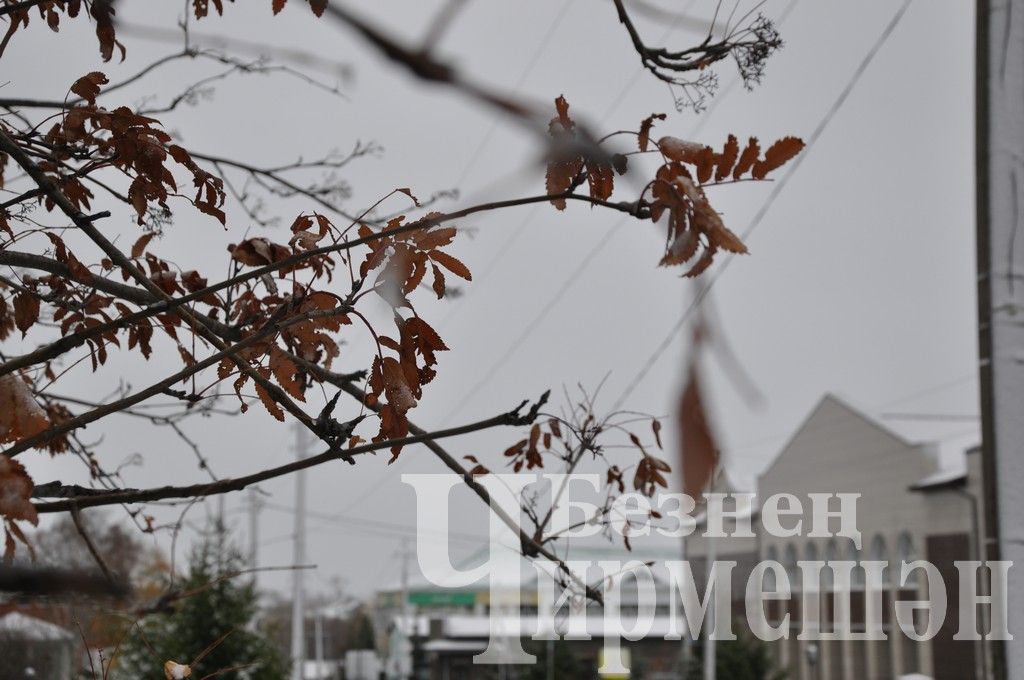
975,0,1024,680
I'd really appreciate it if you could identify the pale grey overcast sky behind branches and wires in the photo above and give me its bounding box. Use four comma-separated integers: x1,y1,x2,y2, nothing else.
12,0,977,594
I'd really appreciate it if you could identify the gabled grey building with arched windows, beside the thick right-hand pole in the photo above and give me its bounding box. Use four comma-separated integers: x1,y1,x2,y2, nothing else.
686,395,991,680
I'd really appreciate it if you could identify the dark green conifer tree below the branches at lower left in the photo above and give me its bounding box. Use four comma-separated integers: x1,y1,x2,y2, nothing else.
116,524,289,680
